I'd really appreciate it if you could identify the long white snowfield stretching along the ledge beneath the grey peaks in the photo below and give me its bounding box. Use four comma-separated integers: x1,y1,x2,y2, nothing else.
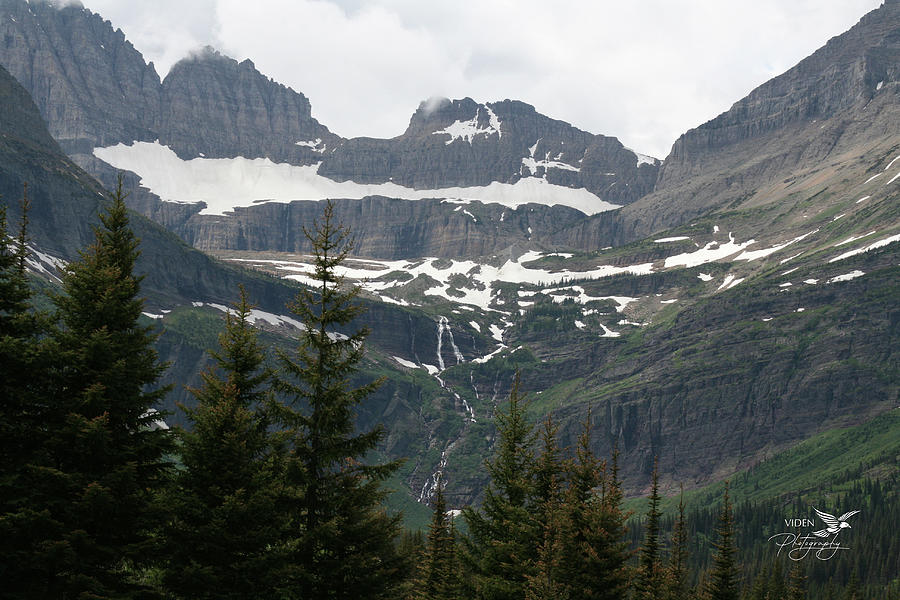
94,141,619,215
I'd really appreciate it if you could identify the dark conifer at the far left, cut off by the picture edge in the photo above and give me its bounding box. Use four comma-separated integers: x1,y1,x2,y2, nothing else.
0,187,64,598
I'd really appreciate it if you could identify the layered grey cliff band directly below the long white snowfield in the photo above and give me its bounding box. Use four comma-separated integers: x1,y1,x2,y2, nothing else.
169,196,584,260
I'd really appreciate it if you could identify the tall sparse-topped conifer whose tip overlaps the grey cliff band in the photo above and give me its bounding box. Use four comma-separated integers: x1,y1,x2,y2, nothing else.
276,202,405,599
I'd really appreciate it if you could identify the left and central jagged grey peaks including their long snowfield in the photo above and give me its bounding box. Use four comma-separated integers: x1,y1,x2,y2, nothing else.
0,0,659,256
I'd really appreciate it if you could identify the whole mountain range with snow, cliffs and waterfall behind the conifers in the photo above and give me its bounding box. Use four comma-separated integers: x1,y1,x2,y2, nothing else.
0,0,900,506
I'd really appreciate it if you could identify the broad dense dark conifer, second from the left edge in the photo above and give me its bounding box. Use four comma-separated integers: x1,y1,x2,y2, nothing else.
39,178,171,597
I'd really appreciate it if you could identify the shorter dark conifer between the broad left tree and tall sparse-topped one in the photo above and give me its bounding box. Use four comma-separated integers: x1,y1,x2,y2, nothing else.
162,286,284,600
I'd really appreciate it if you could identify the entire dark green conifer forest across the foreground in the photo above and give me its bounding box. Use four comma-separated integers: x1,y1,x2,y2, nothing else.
0,189,900,600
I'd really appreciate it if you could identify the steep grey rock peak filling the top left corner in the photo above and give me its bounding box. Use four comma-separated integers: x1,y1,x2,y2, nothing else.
0,0,161,155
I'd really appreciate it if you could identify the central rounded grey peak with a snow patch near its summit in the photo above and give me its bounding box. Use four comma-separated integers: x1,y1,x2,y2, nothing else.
319,98,658,205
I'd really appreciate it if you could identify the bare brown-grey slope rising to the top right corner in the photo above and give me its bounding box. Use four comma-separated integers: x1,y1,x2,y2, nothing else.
557,0,900,245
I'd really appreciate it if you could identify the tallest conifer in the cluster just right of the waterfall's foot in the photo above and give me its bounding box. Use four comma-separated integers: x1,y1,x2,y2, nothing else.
463,372,538,600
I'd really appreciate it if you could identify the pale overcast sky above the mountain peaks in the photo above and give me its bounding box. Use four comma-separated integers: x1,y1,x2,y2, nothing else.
83,0,881,158
